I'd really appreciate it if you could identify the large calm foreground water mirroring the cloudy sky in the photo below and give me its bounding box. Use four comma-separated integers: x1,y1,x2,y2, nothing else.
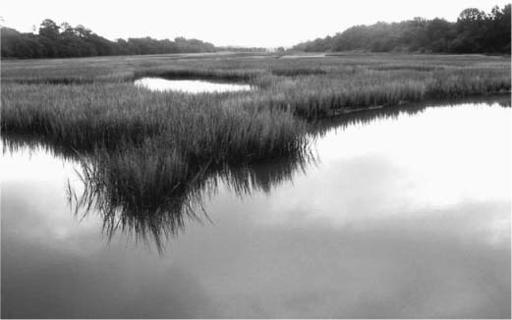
1,99,512,318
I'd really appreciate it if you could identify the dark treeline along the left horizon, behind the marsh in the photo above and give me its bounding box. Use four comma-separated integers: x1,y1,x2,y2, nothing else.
1,19,216,58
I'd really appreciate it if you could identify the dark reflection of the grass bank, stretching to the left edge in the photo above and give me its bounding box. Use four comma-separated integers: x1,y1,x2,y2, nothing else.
2,135,313,252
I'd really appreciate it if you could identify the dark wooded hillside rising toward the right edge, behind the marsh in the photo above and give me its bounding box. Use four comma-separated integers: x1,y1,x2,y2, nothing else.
293,4,510,54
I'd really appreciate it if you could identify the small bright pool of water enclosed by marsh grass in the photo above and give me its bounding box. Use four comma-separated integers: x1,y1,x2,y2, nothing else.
135,77,252,94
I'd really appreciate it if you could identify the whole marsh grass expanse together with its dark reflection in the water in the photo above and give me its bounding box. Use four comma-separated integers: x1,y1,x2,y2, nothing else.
0,55,510,246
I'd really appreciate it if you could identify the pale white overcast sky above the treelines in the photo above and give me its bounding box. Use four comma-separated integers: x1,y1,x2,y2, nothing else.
0,0,510,48
